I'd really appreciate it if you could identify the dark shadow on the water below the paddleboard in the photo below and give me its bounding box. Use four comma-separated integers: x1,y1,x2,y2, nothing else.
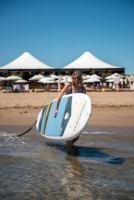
45,143,125,165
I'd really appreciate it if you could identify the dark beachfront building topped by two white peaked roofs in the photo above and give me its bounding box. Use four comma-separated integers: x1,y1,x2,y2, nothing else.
0,52,125,80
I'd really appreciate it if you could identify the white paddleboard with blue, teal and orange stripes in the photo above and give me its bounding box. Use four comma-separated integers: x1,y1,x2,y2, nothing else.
36,93,91,141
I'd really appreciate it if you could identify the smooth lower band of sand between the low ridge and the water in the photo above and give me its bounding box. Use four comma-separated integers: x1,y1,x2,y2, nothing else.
0,106,134,127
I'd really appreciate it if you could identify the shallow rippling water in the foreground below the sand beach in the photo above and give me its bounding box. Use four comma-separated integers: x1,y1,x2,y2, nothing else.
0,126,134,200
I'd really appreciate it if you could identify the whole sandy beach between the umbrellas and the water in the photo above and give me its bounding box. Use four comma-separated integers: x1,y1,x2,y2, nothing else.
0,91,134,127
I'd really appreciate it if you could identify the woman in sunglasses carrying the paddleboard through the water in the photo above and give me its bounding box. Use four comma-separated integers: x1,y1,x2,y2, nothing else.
54,71,86,147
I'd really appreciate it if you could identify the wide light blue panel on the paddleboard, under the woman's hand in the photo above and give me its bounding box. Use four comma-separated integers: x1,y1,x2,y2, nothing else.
44,97,68,137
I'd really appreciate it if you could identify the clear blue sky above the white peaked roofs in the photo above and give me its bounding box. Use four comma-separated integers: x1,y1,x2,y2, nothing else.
0,0,134,75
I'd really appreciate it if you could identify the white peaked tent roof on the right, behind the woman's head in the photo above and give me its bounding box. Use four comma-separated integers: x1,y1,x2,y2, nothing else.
62,52,120,69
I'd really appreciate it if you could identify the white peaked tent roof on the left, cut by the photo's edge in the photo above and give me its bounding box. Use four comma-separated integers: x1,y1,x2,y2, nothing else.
0,52,54,70
